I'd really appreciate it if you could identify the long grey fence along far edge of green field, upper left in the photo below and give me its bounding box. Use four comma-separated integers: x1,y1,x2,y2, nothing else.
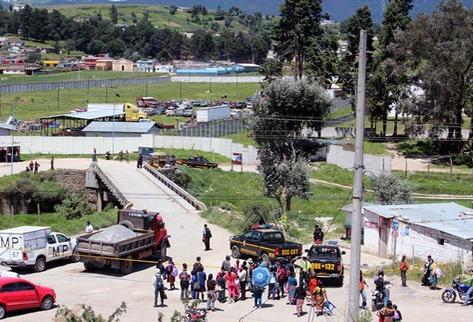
0,76,171,94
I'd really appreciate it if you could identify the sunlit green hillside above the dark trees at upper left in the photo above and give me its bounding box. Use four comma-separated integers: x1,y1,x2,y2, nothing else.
46,4,249,32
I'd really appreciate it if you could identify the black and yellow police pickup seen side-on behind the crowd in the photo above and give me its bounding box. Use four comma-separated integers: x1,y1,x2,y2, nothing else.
230,229,302,262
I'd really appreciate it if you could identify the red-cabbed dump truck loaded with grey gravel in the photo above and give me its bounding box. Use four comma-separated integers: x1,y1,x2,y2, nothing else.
76,209,170,274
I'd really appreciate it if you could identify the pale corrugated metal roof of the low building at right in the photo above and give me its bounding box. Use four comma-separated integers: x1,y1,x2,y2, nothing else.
364,202,473,240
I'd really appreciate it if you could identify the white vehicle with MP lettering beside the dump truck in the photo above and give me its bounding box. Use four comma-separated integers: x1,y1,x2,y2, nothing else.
0,226,79,272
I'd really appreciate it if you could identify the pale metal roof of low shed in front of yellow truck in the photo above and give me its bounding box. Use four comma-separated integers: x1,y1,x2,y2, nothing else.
82,122,160,137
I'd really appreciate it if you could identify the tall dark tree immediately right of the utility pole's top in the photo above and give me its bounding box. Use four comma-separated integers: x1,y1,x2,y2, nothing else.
367,0,412,136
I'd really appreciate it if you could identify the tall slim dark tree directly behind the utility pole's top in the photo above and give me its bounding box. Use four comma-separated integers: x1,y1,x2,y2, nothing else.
339,6,374,106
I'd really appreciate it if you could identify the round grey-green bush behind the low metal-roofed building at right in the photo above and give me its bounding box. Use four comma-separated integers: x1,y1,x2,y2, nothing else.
373,174,412,205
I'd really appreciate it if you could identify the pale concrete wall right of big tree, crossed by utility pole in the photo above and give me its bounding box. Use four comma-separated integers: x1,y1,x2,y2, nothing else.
327,145,391,175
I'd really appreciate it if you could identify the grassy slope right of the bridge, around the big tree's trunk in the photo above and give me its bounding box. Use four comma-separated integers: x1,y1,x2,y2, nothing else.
185,168,348,240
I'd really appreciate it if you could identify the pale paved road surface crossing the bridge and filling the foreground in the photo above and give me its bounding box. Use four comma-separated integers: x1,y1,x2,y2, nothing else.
0,159,471,322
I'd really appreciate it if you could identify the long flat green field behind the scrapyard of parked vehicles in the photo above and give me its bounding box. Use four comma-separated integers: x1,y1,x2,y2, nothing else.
0,82,260,121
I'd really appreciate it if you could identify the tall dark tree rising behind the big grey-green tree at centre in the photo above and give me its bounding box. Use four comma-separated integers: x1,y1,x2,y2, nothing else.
273,0,323,79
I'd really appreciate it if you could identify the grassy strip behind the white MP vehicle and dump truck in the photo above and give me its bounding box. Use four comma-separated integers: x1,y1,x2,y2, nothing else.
0,209,117,235
